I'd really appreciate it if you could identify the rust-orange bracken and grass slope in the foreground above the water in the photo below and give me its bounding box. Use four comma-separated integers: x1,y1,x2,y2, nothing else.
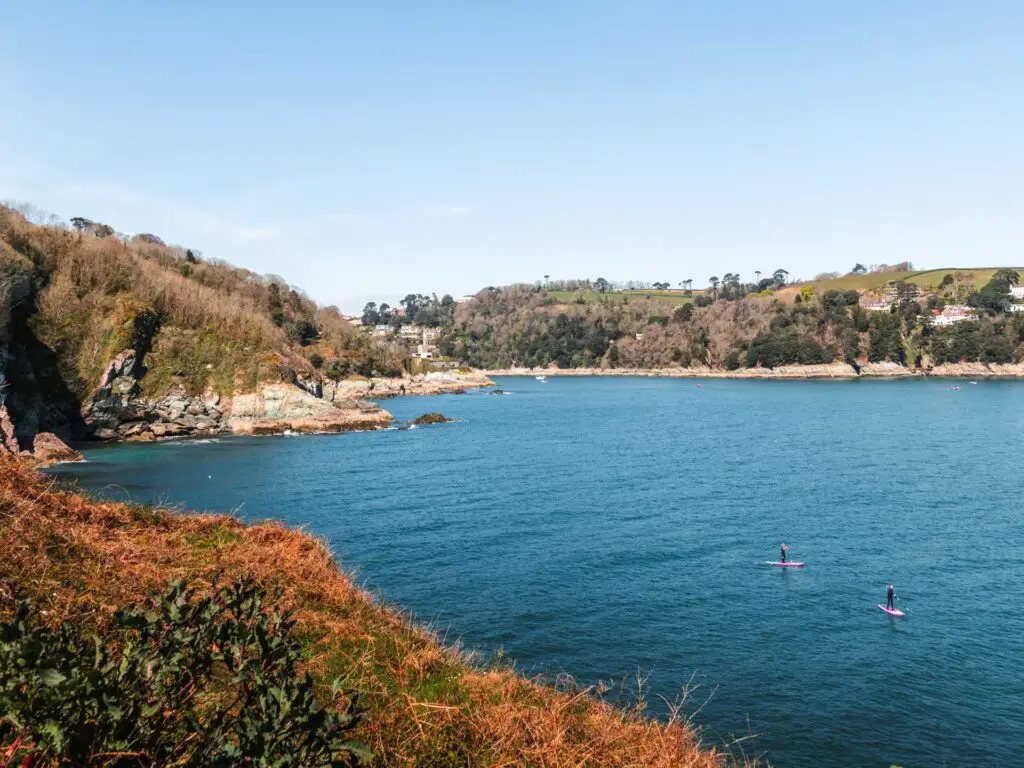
0,457,741,768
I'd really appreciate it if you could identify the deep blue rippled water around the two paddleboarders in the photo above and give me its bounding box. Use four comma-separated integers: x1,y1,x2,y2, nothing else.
49,379,1024,766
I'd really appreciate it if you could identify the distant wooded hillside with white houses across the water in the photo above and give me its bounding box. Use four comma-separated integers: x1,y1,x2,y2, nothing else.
440,268,1024,372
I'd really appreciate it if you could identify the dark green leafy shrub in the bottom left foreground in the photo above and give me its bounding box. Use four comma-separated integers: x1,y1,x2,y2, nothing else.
0,581,369,766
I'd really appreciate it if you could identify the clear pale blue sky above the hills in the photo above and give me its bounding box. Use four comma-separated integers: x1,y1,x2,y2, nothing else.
0,0,1024,311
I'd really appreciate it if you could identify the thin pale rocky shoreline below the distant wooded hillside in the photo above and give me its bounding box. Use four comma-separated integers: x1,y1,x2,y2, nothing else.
480,362,1024,380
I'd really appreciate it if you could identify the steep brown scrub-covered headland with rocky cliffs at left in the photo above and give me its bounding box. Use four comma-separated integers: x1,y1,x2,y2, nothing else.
0,207,403,452
